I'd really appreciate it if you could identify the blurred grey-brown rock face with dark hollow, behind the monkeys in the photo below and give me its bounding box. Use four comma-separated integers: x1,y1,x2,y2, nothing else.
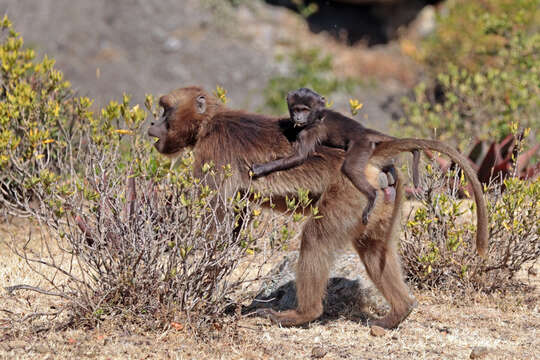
0,0,434,129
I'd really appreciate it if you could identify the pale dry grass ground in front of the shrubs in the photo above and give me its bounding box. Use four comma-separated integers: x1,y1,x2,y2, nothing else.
0,220,540,359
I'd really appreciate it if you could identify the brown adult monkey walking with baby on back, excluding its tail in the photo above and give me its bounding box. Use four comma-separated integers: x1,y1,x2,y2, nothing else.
148,86,490,328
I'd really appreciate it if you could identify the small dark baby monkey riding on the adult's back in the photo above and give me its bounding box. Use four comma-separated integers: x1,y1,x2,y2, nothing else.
251,88,420,224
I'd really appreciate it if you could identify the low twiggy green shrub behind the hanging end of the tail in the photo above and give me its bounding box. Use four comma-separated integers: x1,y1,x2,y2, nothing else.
401,165,540,291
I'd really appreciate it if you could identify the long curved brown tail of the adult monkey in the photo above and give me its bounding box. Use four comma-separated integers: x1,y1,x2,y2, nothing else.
372,138,489,257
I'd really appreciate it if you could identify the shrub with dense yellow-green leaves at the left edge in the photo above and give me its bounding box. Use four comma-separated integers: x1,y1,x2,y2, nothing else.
0,17,92,215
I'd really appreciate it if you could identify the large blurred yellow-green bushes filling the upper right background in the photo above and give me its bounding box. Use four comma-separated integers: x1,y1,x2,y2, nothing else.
399,0,540,147
